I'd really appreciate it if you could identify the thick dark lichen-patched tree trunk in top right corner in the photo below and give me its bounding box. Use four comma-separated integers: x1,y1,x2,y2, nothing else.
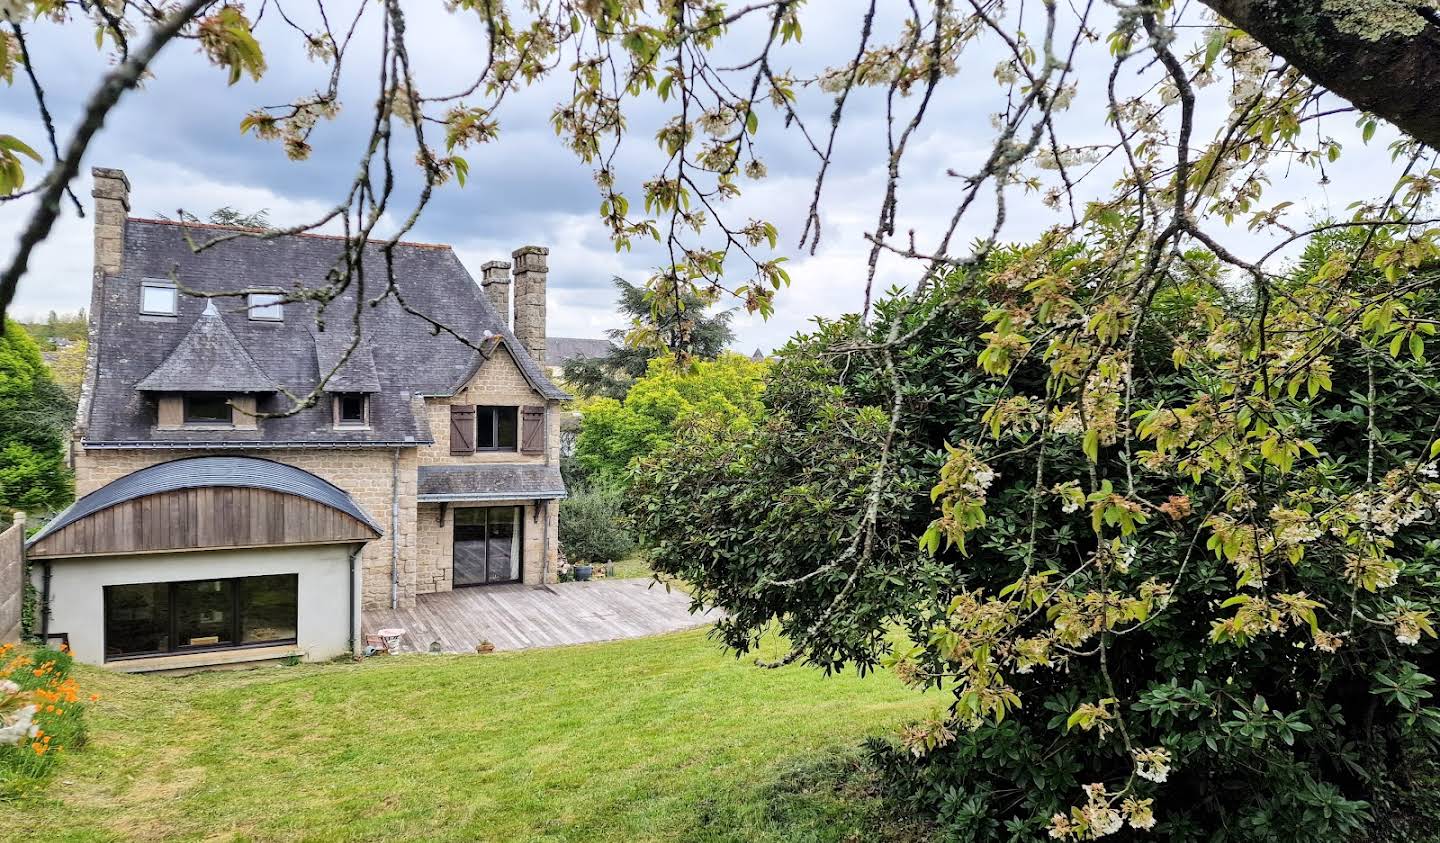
1201,0,1440,148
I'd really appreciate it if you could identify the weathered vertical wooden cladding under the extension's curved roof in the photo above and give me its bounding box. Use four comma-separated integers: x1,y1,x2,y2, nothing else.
29,487,377,558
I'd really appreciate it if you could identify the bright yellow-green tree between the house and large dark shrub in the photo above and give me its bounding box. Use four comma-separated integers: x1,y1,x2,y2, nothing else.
575,353,766,484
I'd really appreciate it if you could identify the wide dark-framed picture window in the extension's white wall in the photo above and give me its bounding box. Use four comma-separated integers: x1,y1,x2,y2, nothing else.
105,574,300,659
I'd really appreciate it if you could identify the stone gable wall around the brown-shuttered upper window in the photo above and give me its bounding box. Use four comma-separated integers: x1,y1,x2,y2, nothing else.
419,347,560,465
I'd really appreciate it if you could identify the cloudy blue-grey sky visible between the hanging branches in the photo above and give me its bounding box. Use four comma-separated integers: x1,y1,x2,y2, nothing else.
0,0,1388,352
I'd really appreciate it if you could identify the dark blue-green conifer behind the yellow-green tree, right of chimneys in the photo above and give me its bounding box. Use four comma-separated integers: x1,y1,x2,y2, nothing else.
564,278,734,401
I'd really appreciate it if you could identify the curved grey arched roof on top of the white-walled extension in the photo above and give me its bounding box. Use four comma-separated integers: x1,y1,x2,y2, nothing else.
26,457,384,546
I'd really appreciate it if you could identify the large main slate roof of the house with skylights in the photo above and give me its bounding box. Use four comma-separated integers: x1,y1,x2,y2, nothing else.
84,218,569,448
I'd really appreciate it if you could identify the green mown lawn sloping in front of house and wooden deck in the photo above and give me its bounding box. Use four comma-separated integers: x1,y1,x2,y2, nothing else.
0,631,933,840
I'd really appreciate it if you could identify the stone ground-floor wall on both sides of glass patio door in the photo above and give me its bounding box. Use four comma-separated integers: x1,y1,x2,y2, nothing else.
415,500,560,594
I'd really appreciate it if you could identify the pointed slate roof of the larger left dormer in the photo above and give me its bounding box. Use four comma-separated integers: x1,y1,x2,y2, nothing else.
135,301,275,393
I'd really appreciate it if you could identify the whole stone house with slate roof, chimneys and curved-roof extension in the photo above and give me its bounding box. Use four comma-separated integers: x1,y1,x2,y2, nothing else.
27,169,569,670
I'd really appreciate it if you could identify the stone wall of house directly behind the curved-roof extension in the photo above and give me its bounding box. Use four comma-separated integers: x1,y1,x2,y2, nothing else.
75,448,426,608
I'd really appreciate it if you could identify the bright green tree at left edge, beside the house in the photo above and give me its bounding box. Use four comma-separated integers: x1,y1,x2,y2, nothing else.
0,321,75,512
